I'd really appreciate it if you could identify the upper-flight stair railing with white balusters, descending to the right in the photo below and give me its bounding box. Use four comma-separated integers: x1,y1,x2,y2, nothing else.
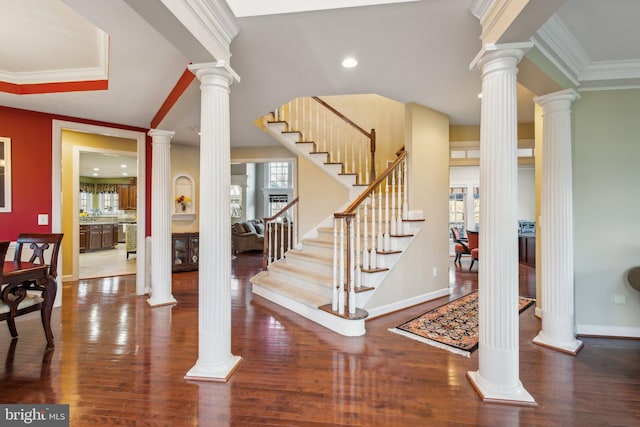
274,96,376,185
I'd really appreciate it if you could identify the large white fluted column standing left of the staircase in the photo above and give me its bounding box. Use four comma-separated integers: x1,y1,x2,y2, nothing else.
185,61,241,381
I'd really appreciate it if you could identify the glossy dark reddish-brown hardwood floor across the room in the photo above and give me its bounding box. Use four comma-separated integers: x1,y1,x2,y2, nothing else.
0,254,640,427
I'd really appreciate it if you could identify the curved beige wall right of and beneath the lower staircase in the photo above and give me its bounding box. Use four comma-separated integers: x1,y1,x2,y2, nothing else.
364,103,449,310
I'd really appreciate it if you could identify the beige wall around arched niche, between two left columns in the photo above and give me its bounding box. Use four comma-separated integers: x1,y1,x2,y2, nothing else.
171,144,200,233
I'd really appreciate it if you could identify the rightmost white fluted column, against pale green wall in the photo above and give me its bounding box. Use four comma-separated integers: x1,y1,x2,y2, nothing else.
533,89,582,355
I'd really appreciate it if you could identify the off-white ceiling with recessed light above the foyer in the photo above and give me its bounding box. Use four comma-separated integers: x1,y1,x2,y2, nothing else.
0,0,640,153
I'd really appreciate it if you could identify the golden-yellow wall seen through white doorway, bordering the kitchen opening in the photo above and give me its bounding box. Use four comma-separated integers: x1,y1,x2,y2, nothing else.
62,129,138,276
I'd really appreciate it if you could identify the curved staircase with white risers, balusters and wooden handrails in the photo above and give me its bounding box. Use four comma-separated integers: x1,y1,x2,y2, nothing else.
251,100,424,336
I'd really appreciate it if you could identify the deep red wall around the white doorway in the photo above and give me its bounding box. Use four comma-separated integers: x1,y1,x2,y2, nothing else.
0,106,151,241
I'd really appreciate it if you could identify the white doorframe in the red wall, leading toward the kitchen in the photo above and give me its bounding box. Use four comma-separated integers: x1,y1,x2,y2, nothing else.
51,119,149,300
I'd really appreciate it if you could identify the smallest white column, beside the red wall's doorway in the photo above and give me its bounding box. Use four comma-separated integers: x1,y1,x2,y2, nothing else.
146,129,177,307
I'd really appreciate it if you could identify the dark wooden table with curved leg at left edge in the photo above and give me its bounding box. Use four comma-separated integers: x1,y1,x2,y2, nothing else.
2,261,58,348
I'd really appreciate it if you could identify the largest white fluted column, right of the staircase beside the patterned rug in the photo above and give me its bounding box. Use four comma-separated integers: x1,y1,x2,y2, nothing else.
467,48,535,404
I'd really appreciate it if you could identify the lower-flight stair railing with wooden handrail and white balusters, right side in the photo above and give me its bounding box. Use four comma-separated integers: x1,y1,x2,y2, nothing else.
331,150,408,317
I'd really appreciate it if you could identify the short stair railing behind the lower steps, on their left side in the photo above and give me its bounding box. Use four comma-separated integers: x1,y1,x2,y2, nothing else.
262,197,298,268
